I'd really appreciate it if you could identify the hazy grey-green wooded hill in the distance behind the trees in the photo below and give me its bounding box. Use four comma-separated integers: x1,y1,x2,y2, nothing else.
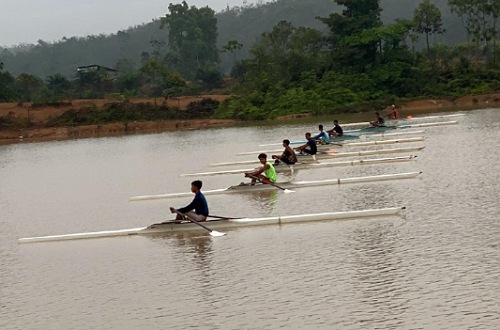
0,0,465,79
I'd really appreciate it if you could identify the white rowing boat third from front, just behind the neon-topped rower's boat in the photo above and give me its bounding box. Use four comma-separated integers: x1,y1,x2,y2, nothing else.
180,155,417,177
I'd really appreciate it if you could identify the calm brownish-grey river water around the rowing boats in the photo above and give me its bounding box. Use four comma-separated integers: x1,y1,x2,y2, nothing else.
0,109,500,330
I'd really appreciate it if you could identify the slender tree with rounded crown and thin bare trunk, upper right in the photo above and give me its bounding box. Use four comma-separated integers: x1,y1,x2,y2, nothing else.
413,0,445,52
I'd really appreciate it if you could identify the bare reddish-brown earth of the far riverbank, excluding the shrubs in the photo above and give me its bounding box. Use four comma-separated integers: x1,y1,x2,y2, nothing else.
0,93,500,143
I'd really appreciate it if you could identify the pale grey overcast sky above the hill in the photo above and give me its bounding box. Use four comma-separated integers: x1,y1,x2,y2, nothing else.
0,0,269,47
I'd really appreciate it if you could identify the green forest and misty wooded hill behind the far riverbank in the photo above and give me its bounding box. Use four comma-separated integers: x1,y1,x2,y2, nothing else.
0,0,500,127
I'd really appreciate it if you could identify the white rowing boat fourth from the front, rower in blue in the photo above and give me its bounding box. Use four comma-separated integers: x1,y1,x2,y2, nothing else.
210,146,425,167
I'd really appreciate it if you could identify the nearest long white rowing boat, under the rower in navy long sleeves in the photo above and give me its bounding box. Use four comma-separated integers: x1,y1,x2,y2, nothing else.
17,207,405,243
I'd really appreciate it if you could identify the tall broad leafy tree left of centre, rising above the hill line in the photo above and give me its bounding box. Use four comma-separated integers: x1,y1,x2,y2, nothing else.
160,1,219,79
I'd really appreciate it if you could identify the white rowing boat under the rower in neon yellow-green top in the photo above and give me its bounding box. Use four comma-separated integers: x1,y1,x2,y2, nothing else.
129,172,422,201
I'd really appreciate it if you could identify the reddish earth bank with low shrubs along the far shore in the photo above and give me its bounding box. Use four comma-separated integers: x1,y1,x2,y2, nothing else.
0,93,500,143
